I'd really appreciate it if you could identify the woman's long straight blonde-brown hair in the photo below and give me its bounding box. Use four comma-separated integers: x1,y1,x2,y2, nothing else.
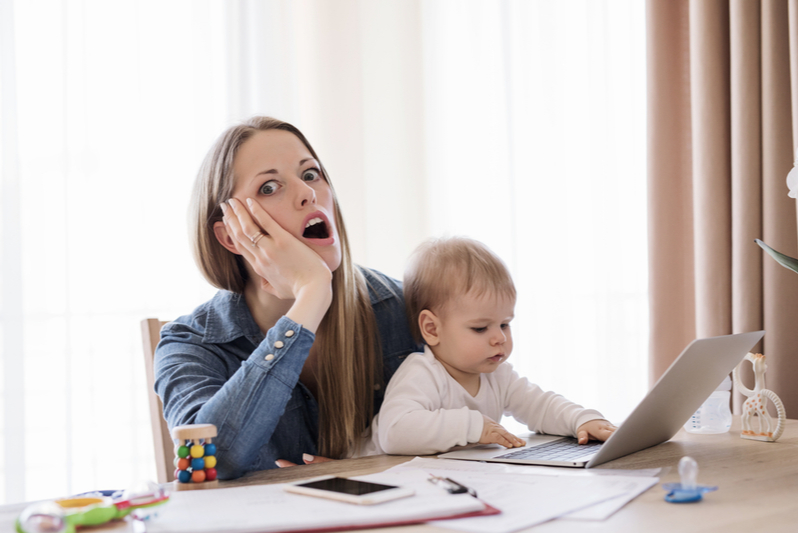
189,117,383,458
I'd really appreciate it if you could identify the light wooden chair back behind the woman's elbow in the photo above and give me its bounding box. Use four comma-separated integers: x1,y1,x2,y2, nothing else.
142,318,175,483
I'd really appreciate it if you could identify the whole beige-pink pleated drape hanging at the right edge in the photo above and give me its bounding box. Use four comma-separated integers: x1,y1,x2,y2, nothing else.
647,0,798,418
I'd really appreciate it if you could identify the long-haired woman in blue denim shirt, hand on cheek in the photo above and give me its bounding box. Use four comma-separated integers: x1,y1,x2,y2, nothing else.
155,117,419,479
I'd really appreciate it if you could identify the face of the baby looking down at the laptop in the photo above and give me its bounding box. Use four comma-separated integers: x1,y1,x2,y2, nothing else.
433,292,516,379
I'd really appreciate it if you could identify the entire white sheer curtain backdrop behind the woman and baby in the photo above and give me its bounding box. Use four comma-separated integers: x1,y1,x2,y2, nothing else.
0,0,647,503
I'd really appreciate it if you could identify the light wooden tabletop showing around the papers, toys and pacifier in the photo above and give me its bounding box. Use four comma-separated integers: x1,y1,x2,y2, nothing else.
0,417,798,533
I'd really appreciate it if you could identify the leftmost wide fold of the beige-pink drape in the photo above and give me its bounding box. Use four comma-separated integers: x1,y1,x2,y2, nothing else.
646,1,695,384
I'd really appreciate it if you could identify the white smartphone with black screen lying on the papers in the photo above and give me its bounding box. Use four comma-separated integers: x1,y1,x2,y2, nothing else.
286,476,414,505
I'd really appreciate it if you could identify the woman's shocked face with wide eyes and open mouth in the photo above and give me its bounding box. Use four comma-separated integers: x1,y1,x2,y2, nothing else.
232,130,342,272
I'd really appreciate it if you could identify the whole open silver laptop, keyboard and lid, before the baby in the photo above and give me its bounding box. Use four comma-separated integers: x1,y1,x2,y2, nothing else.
439,331,764,468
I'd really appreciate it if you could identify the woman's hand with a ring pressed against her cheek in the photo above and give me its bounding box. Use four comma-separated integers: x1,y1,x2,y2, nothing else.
223,198,332,300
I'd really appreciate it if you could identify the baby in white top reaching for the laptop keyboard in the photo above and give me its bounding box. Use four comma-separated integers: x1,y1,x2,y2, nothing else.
372,238,615,455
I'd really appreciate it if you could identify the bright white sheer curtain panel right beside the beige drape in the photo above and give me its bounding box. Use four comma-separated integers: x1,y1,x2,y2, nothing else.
423,0,648,429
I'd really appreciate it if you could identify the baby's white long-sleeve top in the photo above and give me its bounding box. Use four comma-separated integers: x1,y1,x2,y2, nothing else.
368,346,603,455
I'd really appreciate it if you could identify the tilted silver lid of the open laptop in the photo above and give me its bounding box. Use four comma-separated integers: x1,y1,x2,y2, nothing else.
586,331,764,468
